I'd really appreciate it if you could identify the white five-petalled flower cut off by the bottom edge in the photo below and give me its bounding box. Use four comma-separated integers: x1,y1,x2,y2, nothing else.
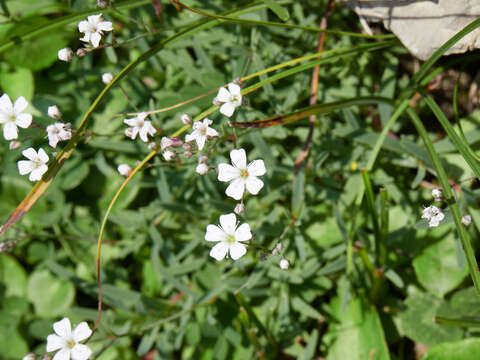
47,318,92,360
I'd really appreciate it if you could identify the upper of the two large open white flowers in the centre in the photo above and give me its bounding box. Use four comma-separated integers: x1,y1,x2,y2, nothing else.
218,149,267,200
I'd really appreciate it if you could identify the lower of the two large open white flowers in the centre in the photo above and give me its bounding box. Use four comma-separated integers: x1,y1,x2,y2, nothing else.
205,213,252,261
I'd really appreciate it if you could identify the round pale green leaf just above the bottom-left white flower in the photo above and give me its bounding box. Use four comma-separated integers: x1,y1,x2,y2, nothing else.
27,270,75,318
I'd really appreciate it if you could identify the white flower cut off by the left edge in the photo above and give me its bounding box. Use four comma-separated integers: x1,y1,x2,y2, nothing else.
0,94,32,140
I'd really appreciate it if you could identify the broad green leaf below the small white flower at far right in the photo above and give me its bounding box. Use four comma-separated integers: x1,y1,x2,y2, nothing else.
413,232,468,297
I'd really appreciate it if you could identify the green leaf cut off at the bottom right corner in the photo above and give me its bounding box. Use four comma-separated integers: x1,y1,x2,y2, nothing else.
422,339,480,360
